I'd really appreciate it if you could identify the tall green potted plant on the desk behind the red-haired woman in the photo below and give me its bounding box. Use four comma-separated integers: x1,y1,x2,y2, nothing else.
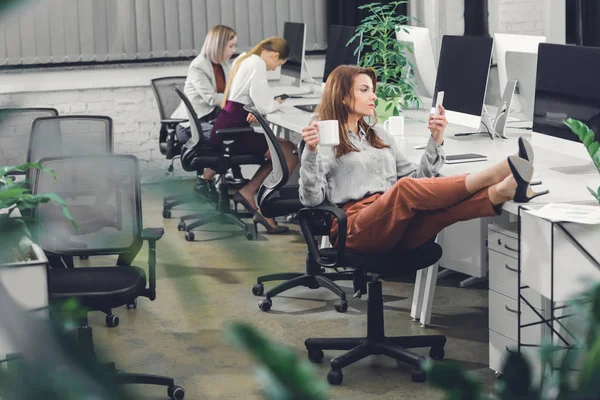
348,0,420,118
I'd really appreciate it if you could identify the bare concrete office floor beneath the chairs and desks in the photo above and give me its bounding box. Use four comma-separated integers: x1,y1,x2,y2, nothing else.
81,181,495,400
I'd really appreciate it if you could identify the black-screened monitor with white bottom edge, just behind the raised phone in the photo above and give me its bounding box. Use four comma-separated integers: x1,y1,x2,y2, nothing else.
432,35,493,132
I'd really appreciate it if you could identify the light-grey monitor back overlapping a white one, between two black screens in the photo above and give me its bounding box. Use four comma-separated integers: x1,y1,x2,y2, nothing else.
506,49,537,121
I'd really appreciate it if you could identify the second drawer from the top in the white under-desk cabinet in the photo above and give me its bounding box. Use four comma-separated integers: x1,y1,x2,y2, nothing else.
488,250,544,310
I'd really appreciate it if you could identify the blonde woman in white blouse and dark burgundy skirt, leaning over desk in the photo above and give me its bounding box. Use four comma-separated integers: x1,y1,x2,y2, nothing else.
211,37,298,233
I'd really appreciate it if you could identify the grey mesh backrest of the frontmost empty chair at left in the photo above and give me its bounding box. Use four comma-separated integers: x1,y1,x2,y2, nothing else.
33,155,142,255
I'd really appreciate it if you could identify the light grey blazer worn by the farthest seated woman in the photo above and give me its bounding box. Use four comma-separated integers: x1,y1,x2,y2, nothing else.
171,55,231,119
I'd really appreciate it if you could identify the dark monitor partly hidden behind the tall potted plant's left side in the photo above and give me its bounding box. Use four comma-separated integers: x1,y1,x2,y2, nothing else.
323,25,361,82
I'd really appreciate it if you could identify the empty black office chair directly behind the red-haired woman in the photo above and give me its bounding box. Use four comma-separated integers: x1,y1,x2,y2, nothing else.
245,106,353,312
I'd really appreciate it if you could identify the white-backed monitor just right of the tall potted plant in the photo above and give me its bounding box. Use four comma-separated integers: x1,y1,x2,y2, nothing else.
396,26,437,98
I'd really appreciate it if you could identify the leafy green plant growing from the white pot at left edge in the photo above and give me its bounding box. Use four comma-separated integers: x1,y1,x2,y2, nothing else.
0,163,78,262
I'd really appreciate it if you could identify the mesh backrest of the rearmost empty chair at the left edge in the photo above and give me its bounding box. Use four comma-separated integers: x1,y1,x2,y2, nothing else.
0,108,58,166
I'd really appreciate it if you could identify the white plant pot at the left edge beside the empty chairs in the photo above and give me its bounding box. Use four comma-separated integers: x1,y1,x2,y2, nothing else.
0,241,49,360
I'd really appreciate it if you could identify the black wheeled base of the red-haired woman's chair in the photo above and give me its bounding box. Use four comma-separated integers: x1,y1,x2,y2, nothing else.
304,281,446,385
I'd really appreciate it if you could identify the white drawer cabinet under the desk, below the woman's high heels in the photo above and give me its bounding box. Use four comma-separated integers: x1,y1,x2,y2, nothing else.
488,222,544,377
